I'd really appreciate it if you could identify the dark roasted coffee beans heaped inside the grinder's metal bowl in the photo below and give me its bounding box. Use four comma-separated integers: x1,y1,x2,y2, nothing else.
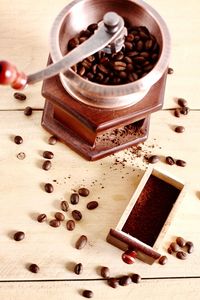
67,24,160,85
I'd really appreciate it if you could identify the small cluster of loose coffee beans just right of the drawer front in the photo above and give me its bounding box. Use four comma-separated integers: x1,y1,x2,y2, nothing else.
167,236,194,260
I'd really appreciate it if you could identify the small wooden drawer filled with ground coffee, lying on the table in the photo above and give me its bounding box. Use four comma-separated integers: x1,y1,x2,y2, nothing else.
107,167,186,264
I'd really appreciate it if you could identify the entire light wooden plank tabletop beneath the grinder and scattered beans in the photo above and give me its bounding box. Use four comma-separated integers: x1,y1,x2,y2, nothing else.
0,0,200,300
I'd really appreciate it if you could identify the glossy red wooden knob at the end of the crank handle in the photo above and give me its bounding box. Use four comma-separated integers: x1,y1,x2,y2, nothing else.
0,60,27,89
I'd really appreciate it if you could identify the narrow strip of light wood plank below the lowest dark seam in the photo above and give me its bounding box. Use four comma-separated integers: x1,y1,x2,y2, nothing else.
0,278,200,300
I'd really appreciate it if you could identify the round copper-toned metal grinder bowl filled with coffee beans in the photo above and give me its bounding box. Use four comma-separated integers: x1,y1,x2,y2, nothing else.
50,0,171,109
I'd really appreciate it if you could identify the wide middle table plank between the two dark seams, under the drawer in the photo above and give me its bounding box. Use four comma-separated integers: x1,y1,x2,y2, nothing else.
0,111,200,280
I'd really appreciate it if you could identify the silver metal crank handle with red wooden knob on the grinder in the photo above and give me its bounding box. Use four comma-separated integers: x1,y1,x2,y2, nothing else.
0,12,124,89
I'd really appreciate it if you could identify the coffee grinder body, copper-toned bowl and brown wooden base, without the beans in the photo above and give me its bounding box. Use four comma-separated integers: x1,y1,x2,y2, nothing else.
0,0,170,160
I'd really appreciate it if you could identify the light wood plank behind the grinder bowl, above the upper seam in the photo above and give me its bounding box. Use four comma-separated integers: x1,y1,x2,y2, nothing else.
0,0,200,109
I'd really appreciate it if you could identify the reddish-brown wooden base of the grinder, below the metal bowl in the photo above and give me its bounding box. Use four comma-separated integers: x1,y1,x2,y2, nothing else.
42,60,167,160
